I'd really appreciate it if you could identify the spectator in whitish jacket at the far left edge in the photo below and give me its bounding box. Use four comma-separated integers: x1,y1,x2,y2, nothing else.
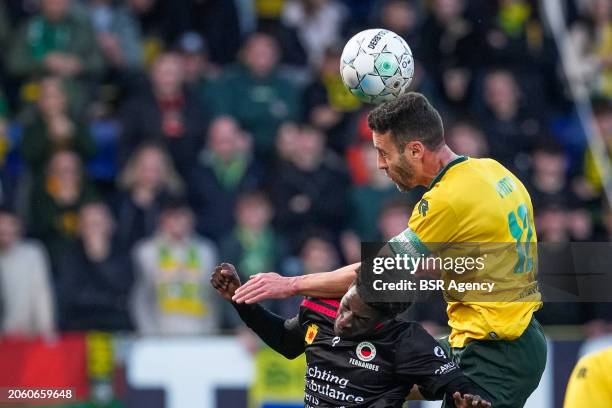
0,207,56,338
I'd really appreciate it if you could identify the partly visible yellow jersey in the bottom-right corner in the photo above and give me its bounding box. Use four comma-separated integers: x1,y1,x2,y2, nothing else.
563,347,612,408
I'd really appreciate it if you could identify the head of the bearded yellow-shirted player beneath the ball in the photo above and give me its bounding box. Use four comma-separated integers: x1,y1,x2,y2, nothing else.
368,92,445,191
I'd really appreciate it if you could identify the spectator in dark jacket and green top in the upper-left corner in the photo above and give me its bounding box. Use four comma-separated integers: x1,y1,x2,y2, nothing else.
7,0,104,108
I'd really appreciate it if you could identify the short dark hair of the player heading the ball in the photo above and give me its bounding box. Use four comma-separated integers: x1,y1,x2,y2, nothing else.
368,92,444,153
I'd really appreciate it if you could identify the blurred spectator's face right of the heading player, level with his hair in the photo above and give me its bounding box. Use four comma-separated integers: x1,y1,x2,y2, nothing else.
485,71,519,118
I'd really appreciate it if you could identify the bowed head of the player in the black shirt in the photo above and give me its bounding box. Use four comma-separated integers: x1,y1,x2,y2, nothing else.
334,270,410,338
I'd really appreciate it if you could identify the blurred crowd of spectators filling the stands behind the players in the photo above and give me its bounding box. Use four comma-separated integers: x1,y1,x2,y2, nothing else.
0,0,612,337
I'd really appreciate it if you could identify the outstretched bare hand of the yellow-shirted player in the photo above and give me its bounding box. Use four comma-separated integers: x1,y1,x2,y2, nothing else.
232,272,295,304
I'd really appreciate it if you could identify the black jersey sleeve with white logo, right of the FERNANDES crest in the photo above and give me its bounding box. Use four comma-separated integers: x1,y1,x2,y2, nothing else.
395,325,463,399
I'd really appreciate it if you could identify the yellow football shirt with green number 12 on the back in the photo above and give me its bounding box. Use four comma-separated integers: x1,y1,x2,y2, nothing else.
391,156,542,347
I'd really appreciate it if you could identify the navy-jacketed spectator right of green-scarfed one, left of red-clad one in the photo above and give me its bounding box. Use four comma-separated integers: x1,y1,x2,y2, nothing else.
270,126,349,249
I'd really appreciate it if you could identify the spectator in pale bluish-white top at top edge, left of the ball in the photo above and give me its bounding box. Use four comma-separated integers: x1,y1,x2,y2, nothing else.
282,0,348,67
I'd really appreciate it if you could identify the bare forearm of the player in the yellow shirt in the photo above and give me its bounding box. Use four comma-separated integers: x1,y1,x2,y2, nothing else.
292,263,361,298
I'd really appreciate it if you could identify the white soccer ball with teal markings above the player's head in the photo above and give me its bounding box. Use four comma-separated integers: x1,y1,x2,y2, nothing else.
340,28,414,104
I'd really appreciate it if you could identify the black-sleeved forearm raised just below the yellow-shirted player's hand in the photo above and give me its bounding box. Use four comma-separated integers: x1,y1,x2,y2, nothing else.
232,302,304,358
